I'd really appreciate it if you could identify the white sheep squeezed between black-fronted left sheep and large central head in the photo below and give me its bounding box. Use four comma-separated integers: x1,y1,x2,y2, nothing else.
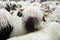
10,10,26,37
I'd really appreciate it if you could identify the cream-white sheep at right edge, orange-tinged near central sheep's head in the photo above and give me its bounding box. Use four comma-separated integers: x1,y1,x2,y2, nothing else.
44,6,60,23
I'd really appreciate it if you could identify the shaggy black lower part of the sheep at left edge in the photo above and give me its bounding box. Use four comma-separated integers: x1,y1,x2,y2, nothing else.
0,23,13,40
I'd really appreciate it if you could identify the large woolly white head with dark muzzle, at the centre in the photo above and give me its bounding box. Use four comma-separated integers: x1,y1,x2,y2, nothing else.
22,6,43,32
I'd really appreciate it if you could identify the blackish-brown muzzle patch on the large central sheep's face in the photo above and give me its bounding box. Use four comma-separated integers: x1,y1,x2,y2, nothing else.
25,17,38,32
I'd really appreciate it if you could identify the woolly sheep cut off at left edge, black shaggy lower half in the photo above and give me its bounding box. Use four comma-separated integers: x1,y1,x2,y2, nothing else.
0,9,13,40
